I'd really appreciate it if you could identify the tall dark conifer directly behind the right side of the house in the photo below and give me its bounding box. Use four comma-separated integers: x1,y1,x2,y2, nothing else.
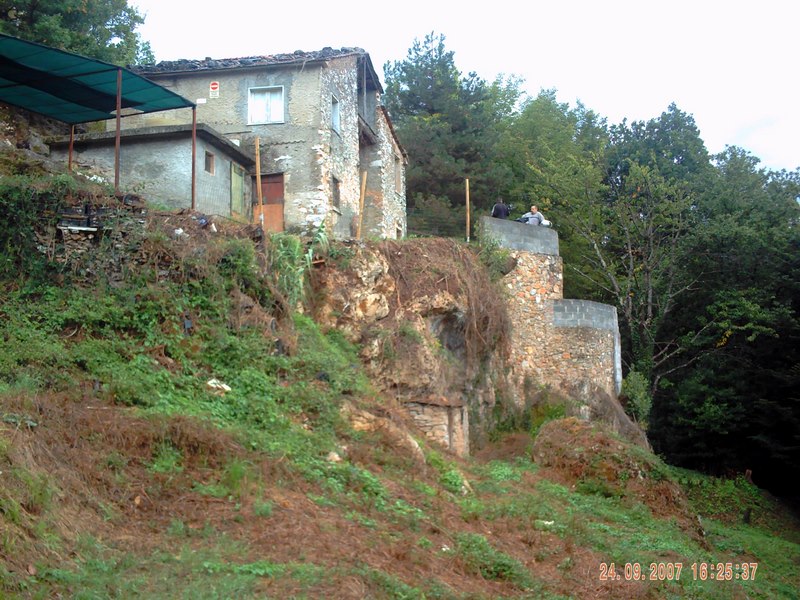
384,33,521,220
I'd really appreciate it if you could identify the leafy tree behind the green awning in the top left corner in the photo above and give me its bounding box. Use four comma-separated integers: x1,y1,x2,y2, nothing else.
0,0,153,65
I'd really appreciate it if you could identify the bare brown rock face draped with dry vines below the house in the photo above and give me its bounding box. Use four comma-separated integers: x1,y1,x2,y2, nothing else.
315,240,505,455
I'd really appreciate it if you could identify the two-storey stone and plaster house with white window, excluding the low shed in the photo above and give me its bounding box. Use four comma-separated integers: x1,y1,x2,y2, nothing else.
122,48,407,239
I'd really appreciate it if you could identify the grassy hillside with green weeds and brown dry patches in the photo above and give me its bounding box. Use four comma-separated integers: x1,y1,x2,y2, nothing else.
0,166,800,599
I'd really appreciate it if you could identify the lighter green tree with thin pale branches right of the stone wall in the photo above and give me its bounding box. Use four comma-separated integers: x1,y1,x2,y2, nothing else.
572,163,692,389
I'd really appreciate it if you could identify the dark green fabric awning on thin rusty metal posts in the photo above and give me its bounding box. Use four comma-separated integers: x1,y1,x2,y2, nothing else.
0,34,195,125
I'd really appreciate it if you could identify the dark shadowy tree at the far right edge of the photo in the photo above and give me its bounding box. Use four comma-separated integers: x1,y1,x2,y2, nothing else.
651,147,800,491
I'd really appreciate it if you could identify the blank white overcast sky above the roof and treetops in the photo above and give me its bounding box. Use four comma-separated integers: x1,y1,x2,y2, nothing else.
129,0,800,170
